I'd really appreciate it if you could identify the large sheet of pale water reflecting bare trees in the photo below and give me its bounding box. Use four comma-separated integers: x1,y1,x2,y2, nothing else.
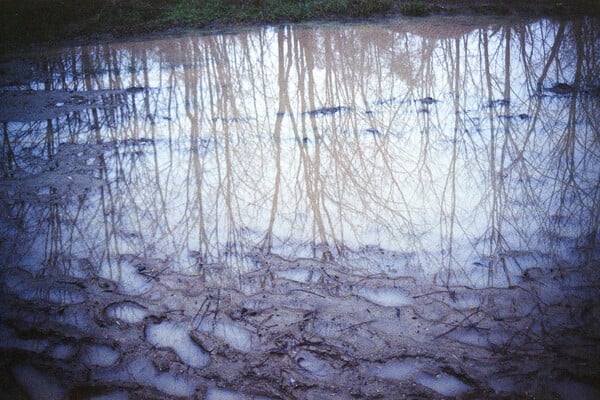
1,19,600,285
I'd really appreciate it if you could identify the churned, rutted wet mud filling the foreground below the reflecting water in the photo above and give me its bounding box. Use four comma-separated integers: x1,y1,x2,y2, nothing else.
2,254,600,398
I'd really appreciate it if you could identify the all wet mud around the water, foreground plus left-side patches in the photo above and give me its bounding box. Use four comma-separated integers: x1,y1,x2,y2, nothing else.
0,14,600,399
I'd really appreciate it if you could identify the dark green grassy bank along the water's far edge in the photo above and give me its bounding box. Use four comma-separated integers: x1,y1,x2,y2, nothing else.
0,0,600,51
